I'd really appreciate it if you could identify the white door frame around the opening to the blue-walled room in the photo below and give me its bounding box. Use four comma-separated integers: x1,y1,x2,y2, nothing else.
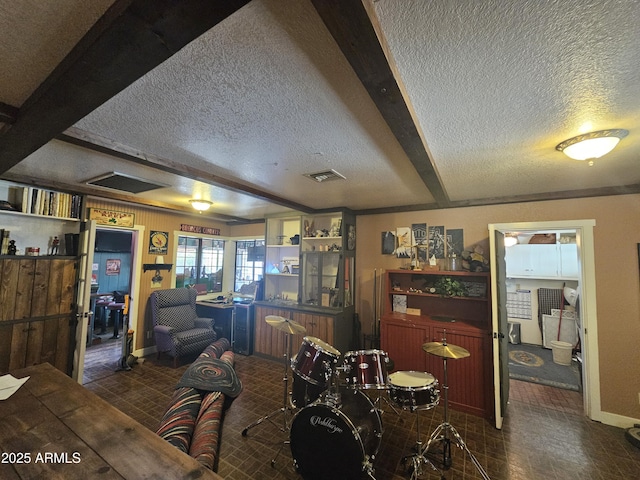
72,220,145,384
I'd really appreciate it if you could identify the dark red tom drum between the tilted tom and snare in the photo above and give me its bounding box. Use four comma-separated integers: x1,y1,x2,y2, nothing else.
344,350,389,389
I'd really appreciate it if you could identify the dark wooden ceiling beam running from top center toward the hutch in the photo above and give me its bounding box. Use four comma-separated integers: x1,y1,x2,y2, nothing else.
311,0,449,208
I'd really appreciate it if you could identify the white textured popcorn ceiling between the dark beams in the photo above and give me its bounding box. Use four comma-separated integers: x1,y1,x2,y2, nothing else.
0,0,640,220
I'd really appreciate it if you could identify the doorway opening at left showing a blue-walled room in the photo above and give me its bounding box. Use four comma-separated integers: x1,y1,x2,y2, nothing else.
82,227,137,384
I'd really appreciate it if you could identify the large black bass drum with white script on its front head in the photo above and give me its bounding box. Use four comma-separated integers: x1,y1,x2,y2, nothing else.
290,387,382,480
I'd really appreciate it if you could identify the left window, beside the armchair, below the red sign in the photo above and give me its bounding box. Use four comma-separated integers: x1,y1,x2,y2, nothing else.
176,236,224,292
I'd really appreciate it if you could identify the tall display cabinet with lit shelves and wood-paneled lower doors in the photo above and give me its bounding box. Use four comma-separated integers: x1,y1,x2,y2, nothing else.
254,210,355,358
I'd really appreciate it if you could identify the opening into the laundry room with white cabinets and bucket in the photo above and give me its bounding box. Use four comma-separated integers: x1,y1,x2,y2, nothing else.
505,230,585,404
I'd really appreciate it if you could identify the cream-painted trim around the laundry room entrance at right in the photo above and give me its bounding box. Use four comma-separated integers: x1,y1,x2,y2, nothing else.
489,219,604,428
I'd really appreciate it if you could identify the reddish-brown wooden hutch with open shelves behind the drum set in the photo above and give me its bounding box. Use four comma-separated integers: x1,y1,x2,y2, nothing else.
380,270,493,418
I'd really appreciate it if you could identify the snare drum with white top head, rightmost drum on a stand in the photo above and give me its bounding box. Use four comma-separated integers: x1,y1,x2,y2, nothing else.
389,371,440,410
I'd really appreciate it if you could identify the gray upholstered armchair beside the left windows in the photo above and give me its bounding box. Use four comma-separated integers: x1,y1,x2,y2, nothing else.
151,288,217,367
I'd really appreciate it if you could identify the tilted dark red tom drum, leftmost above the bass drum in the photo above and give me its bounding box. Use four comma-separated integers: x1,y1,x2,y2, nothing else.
291,337,340,385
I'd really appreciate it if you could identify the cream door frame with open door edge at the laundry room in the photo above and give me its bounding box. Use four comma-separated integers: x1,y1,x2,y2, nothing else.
489,220,601,428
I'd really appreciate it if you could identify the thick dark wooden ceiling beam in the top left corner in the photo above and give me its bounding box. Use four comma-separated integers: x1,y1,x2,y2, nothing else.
0,0,249,174
